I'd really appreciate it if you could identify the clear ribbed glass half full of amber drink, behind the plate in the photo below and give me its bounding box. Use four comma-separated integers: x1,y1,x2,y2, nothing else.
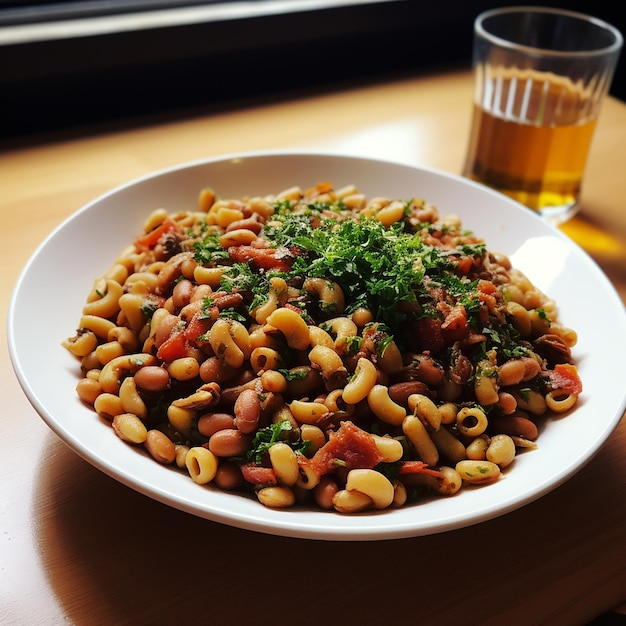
464,7,623,223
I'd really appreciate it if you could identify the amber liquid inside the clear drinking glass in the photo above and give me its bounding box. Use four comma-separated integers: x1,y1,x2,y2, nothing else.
465,71,596,219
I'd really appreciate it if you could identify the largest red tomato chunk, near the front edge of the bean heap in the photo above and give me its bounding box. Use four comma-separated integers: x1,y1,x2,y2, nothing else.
309,422,382,475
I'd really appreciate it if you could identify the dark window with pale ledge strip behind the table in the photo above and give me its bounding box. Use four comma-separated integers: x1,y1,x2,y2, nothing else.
0,0,623,140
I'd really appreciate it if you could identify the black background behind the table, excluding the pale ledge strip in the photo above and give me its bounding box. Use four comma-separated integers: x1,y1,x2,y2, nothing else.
0,0,626,141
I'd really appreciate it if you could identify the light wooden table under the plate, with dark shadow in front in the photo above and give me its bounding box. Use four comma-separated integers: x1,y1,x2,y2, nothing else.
0,71,626,626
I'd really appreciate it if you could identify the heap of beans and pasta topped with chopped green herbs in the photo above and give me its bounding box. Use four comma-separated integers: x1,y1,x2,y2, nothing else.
64,184,582,513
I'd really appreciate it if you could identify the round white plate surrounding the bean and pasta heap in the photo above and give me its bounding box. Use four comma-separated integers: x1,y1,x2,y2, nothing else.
7,153,626,540
